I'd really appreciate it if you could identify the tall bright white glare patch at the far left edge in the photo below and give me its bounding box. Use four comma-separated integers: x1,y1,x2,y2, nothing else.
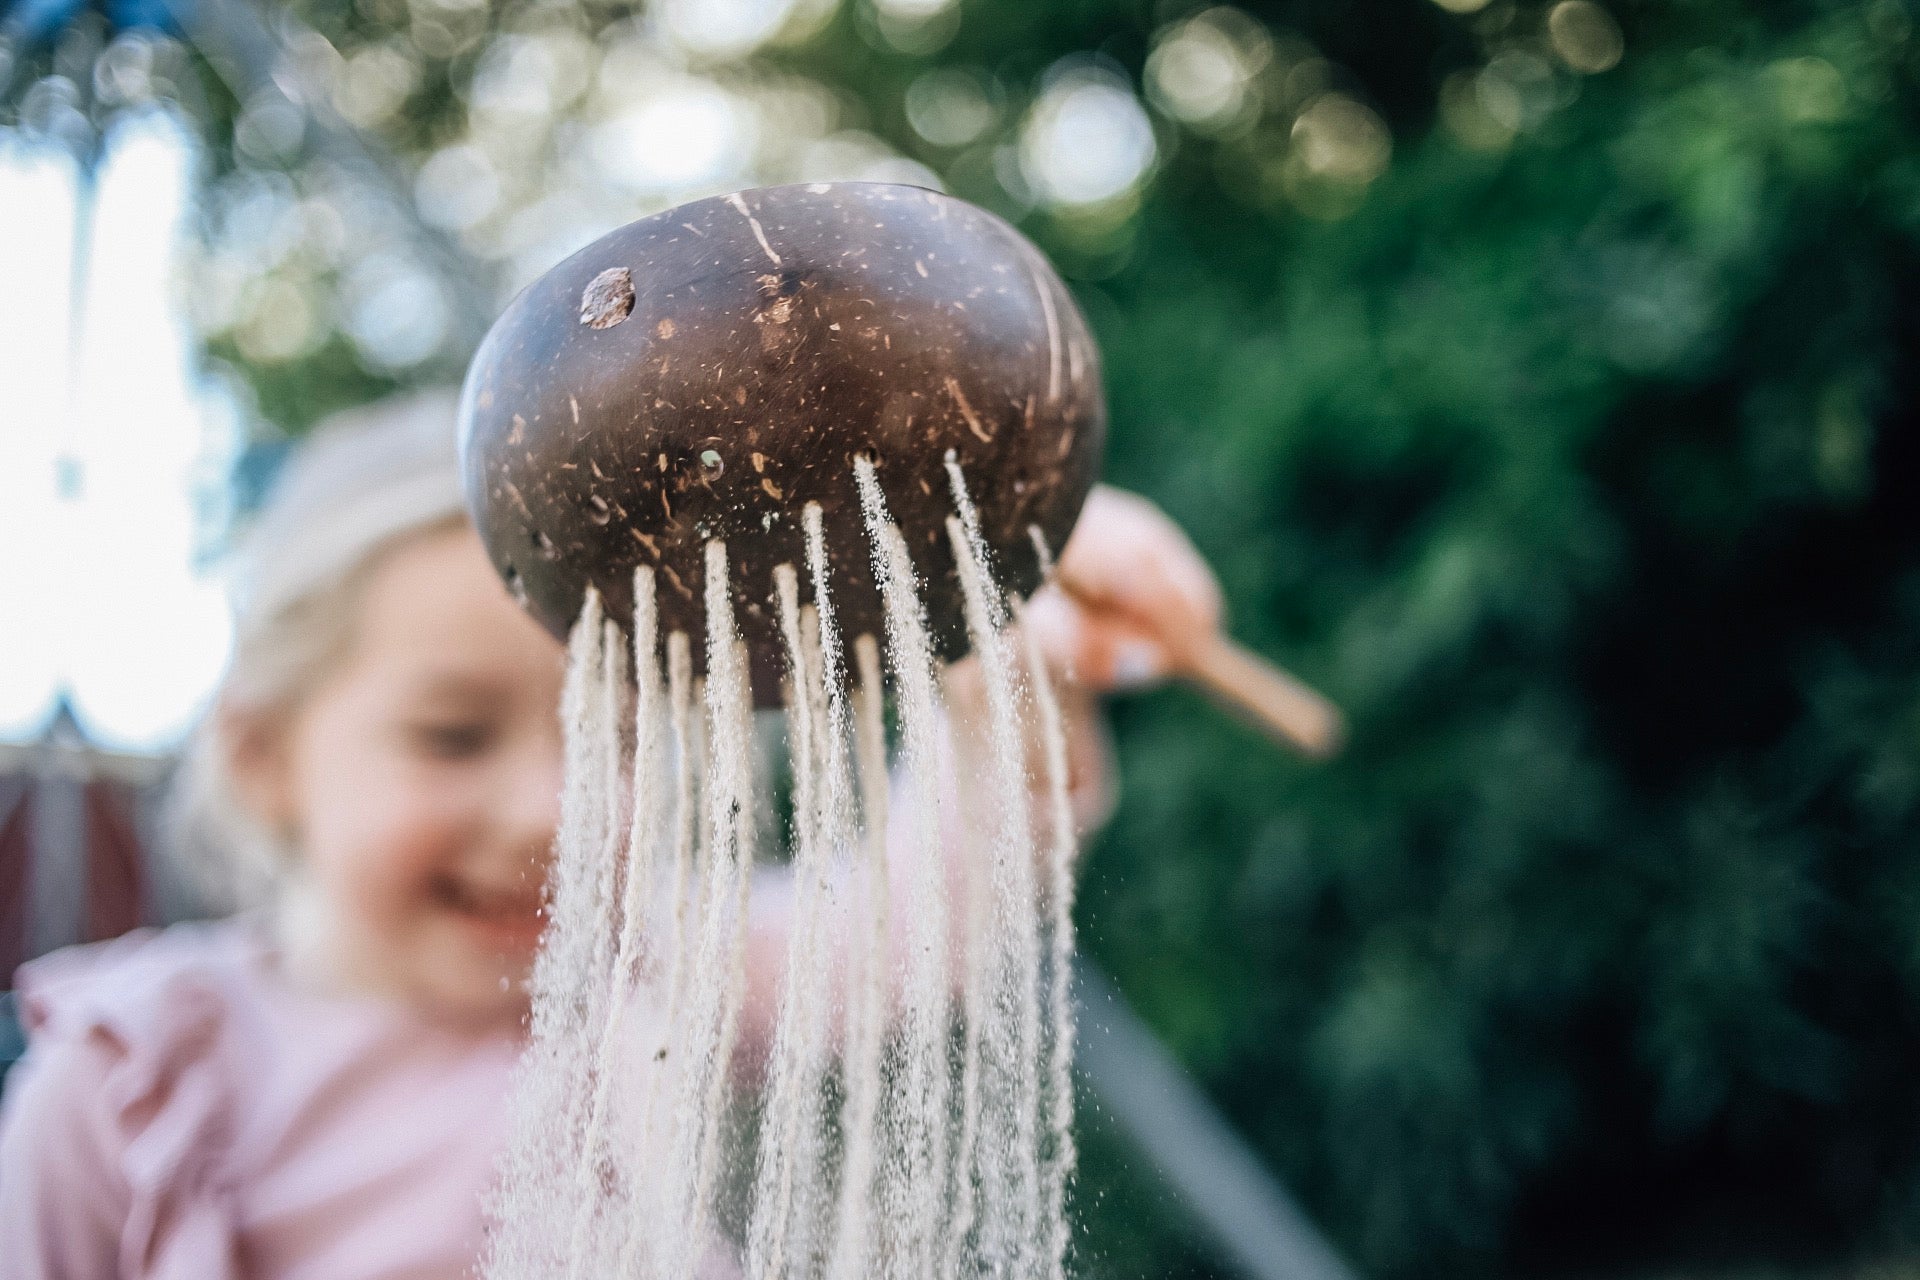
0,115,228,750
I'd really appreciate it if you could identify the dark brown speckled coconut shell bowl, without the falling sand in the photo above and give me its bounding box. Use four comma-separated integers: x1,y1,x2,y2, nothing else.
461,182,1106,702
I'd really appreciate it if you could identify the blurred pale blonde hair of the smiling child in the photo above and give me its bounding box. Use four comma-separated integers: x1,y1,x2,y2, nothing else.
169,390,467,910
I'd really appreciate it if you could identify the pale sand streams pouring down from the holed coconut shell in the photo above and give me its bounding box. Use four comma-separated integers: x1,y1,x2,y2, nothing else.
486,457,1073,1280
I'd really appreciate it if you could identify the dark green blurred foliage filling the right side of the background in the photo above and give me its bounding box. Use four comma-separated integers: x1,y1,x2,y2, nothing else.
15,0,1920,1276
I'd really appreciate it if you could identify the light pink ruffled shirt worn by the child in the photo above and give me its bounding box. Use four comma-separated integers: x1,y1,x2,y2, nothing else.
0,921,518,1280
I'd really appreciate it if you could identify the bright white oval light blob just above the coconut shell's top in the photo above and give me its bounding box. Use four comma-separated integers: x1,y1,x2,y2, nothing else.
593,81,753,196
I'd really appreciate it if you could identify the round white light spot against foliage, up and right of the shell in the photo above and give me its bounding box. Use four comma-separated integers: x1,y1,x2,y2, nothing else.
1020,69,1154,205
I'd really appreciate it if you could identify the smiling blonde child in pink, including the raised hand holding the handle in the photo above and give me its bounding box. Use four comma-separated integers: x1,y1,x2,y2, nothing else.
0,395,1219,1280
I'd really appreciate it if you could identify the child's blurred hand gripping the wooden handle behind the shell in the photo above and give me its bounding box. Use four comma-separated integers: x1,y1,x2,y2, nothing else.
1027,486,1221,691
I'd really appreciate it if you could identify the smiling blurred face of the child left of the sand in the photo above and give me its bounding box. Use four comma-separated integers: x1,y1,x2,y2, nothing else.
243,526,563,1019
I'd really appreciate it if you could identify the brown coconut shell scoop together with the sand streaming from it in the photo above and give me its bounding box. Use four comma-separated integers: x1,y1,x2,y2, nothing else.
449,182,1106,1280
